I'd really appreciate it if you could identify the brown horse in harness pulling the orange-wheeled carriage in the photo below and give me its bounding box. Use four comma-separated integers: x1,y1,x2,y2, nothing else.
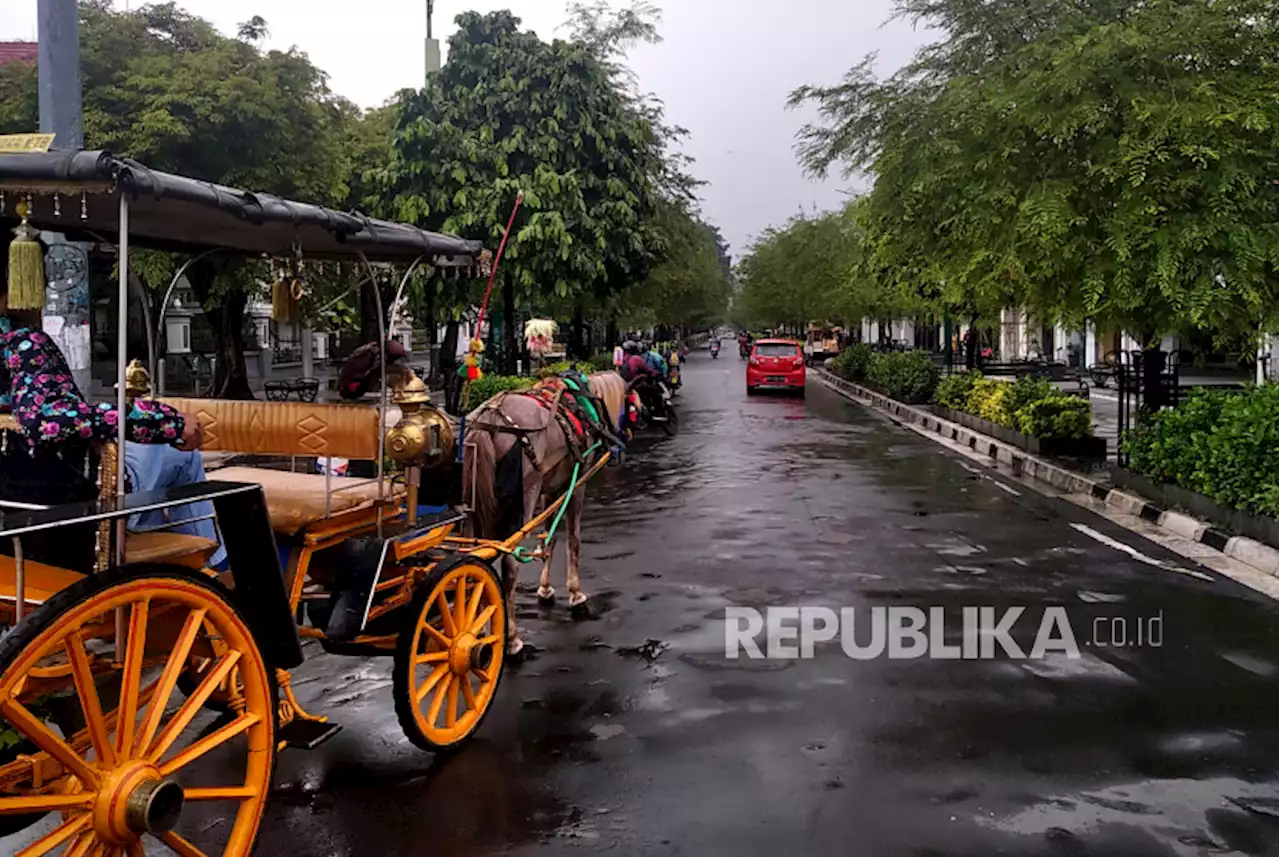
462,372,627,655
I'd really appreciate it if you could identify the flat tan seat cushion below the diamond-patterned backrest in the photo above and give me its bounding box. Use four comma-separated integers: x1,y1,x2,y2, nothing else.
218,467,404,536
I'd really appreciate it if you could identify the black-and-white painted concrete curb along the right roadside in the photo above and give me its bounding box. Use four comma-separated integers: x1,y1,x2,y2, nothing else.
810,368,1280,577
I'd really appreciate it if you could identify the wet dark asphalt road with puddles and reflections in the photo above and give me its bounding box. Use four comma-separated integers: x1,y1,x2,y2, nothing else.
257,353,1280,857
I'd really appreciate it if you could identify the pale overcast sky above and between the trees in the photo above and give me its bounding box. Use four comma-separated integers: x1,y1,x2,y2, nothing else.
0,0,924,256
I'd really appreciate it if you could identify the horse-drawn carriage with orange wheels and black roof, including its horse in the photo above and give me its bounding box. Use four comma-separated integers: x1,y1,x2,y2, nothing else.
0,152,625,857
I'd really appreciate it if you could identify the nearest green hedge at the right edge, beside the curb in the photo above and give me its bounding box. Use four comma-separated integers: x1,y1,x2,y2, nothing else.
1121,384,1280,518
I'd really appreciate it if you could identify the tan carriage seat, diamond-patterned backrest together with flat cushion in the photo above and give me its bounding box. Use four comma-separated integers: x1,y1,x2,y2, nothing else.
161,398,403,536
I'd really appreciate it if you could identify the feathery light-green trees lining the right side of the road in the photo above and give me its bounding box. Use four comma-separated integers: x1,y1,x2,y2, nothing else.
740,0,1280,391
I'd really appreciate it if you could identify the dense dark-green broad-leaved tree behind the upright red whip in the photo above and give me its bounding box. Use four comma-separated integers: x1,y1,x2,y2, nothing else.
379,12,668,368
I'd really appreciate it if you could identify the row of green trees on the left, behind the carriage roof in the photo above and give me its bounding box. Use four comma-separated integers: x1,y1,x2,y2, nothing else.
0,0,728,398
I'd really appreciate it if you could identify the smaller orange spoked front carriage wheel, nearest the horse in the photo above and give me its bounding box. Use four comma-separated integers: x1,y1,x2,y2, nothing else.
394,556,507,752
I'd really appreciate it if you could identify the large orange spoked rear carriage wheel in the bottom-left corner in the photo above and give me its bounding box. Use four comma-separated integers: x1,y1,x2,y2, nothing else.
0,565,275,857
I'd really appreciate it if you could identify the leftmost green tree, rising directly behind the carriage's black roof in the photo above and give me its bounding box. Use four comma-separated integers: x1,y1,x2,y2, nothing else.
0,0,364,398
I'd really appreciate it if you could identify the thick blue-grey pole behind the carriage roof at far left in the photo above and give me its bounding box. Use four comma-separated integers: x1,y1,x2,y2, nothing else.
36,0,93,395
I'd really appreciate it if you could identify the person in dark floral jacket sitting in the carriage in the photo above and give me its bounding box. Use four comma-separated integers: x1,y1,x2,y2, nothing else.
0,269,201,570
